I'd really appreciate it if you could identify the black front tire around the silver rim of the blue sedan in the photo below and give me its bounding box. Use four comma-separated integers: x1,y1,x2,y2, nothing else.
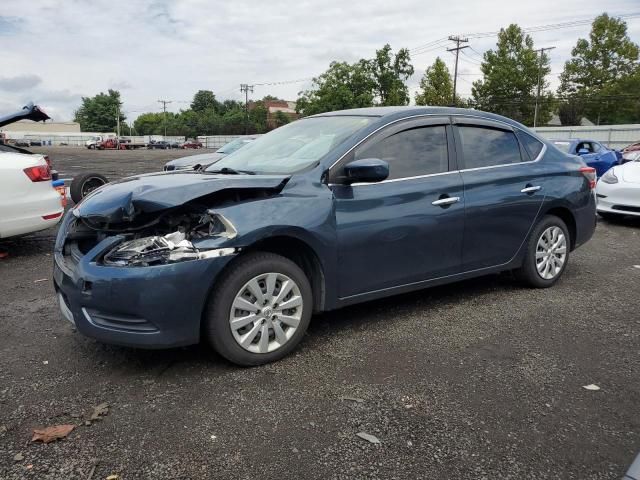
203,252,313,366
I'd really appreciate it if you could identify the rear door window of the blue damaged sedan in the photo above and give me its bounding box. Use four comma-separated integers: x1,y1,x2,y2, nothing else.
457,125,522,169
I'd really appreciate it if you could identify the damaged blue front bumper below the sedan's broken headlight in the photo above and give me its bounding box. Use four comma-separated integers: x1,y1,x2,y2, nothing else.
53,215,235,348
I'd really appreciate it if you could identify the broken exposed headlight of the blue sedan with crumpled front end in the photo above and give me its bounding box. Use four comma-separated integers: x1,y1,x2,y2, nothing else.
103,231,237,267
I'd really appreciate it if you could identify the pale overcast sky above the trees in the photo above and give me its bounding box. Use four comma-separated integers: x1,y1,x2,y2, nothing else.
0,0,640,121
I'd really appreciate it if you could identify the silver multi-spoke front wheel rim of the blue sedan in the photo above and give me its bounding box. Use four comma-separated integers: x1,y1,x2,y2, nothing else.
229,272,303,354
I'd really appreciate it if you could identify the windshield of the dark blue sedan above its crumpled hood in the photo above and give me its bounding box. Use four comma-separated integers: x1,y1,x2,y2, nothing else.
206,116,377,174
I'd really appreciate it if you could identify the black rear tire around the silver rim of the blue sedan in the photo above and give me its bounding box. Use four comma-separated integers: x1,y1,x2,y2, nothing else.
514,215,571,288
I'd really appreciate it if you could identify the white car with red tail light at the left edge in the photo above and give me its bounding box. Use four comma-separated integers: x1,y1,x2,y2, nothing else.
0,152,64,238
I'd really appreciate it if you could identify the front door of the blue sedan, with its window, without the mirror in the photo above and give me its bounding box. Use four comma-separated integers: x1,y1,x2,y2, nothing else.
331,117,464,298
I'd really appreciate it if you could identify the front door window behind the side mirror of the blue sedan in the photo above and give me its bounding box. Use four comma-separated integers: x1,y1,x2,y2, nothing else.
355,125,448,180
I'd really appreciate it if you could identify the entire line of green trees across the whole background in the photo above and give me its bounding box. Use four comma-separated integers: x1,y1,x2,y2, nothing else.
75,13,640,137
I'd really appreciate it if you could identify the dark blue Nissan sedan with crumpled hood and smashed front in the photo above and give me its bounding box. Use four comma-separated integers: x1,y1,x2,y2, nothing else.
54,107,596,365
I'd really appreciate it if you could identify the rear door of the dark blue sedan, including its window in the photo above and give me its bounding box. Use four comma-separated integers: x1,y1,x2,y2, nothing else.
454,117,544,271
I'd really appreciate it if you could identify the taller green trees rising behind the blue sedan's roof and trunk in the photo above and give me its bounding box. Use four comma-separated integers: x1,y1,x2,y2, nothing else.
297,13,640,125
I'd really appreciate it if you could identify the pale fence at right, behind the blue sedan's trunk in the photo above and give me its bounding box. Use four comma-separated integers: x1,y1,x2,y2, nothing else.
533,124,640,149
